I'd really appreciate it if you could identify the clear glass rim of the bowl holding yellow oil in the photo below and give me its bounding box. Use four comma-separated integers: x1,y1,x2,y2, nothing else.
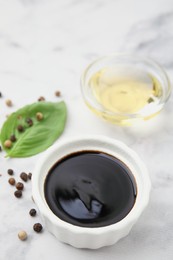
80,52,172,119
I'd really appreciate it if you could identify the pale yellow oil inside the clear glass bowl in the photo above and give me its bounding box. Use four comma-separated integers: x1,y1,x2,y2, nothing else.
89,67,162,124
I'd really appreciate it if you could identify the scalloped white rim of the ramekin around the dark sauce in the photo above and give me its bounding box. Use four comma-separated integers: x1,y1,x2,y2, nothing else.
32,135,151,235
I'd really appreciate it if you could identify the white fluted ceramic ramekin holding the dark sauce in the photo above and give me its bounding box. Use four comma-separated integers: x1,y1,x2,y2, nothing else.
32,136,151,249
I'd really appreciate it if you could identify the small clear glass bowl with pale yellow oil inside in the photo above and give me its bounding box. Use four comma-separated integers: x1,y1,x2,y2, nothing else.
81,54,171,125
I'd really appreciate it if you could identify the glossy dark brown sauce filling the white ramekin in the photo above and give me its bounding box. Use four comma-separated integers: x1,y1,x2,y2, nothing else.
44,151,137,227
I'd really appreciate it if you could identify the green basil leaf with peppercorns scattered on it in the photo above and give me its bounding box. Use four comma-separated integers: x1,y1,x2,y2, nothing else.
0,101,67,157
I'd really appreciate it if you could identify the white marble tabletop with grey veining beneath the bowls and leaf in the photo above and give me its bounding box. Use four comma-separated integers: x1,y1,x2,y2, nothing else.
0,0,173,260
